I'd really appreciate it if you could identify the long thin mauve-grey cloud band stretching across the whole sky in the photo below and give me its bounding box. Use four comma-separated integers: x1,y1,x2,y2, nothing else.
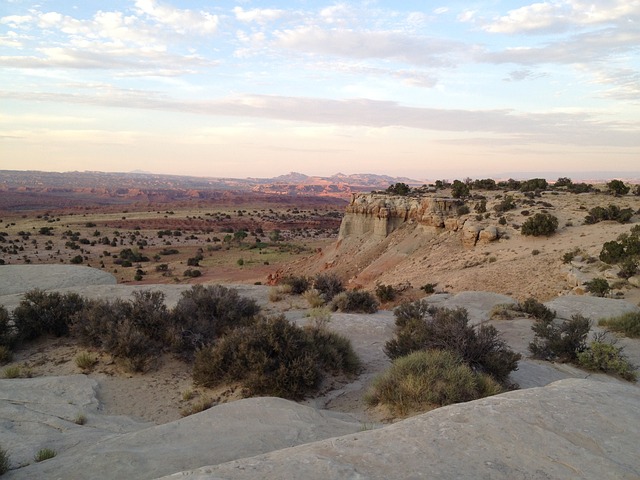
0,89,640,148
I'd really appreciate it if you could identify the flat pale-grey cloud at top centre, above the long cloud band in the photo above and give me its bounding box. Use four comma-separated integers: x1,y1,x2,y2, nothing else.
275,26,464,66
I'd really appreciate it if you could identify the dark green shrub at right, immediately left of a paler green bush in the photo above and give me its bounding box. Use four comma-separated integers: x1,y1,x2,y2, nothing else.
529,315,591,362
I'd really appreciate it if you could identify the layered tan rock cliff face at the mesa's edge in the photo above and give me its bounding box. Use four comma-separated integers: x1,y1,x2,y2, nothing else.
338,193,461,239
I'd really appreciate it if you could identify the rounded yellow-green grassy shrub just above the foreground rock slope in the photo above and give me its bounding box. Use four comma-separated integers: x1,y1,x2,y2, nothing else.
365,350,502,415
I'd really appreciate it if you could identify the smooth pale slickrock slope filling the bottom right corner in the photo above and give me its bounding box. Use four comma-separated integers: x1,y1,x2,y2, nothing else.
161,379,640,480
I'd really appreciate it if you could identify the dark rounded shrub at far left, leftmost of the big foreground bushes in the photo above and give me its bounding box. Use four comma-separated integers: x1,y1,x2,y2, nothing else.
13,289,84,340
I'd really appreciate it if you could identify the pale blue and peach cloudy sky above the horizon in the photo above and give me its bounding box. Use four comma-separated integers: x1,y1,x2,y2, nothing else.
0,0,640,179
